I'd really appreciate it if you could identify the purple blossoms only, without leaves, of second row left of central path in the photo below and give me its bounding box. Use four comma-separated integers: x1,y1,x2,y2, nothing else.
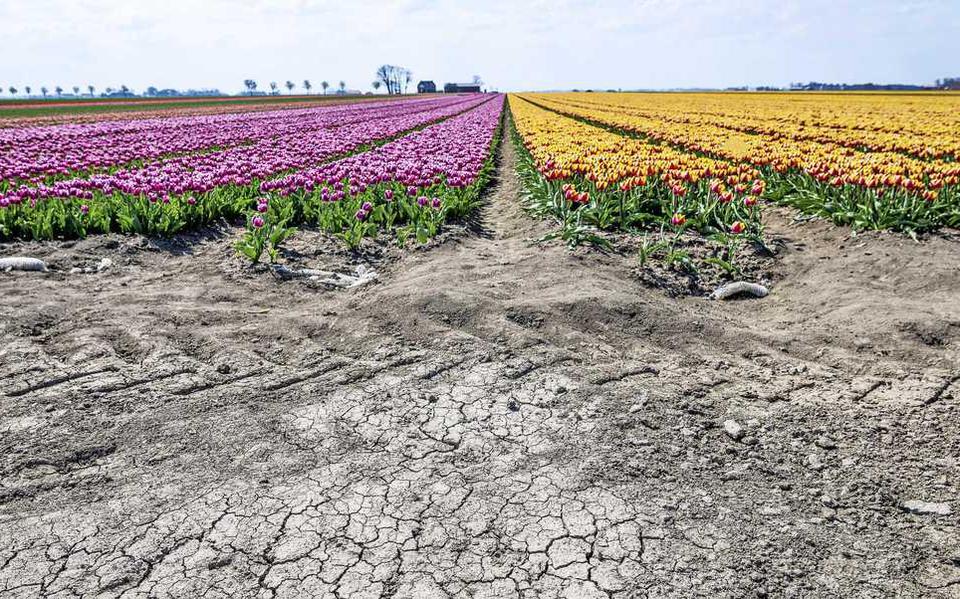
0,95,489,208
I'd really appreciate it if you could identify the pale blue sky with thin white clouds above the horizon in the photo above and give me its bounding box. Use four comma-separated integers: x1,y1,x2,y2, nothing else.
0,0,960,96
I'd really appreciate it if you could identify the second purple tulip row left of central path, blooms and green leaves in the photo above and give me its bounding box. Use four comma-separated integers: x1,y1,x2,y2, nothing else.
0,96,488,239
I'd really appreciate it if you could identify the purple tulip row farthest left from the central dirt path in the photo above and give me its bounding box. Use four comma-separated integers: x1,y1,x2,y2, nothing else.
0,97,480,182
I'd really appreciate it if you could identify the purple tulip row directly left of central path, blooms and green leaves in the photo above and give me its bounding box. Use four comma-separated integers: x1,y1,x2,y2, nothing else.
238,95,504,262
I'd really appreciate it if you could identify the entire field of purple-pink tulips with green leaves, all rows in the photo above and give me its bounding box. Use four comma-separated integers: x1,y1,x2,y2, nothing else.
0,94,504,251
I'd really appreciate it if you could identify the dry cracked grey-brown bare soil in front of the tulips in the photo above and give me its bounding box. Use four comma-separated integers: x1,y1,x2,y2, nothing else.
0,136,960,599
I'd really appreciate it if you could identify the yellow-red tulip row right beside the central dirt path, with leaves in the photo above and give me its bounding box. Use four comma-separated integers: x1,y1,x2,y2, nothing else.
510,96,765,274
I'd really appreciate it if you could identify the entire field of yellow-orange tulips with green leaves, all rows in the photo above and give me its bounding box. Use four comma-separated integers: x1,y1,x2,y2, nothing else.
510,93,960,262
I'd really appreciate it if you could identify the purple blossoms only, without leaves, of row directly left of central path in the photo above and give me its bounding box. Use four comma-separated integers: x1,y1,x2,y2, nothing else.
260,95,504,195
